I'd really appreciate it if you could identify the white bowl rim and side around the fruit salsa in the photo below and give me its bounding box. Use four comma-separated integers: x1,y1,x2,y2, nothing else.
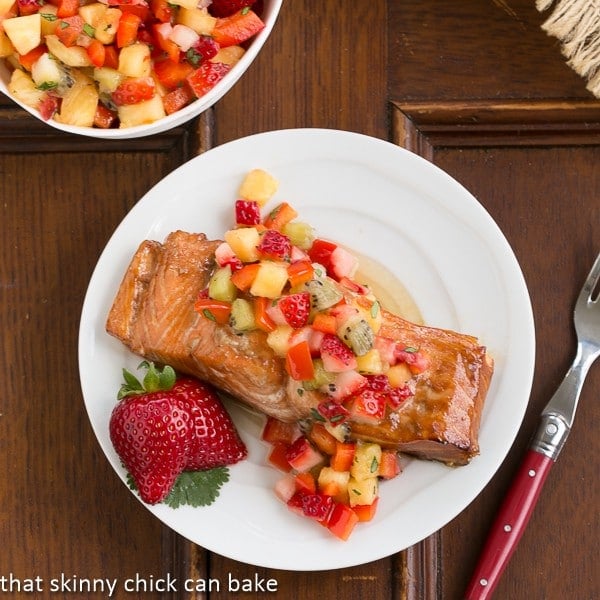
0,0,282,140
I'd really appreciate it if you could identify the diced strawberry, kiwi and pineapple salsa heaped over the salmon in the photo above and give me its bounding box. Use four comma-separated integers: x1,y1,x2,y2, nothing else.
195,169,428,540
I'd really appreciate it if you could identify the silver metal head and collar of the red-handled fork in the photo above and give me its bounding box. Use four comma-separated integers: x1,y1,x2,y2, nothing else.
531,254,600,460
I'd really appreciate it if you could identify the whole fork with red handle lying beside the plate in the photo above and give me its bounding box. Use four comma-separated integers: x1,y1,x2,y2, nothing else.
464,255,600,600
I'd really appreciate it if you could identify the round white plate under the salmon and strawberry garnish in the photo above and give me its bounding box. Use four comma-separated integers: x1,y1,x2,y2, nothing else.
79,129,535,571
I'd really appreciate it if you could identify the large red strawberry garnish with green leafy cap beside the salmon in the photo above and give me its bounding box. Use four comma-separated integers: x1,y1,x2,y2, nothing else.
109,362,247,504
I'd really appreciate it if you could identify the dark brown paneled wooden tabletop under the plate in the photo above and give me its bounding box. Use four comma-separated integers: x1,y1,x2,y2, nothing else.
0,0,600,600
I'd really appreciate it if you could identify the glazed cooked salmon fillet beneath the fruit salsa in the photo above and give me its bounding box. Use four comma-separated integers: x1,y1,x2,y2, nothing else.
106,231,493,465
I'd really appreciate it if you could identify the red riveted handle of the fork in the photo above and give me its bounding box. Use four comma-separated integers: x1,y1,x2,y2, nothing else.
465,449,554,600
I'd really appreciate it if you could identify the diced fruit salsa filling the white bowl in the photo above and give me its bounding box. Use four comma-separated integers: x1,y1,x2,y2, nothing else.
0,0,265,129
